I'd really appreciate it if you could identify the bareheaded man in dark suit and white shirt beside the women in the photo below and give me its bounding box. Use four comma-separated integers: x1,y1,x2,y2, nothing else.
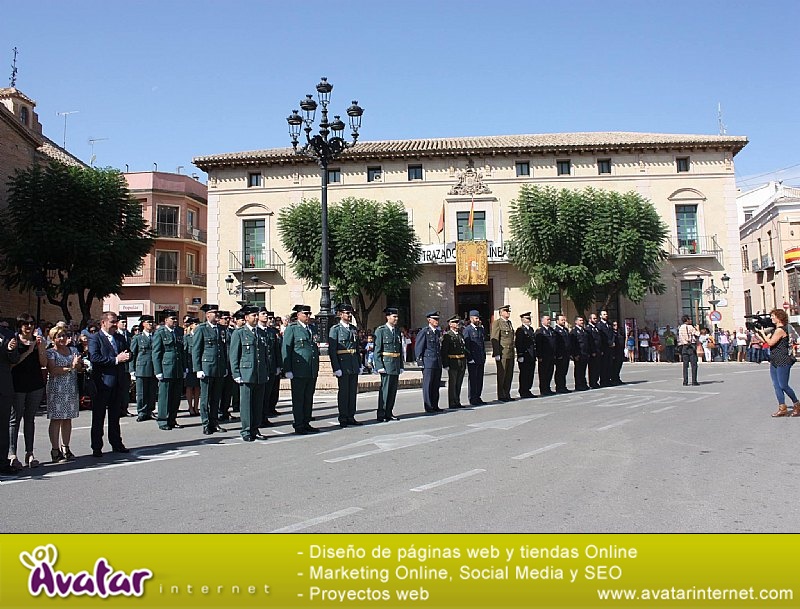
89,311,131,457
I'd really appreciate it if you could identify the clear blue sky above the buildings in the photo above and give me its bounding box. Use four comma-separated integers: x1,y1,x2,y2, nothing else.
0,0,800,188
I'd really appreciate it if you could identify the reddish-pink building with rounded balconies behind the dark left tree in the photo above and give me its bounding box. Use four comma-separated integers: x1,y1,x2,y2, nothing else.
103,172,208,327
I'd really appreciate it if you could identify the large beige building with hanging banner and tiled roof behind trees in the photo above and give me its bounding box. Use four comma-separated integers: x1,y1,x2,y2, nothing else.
195,132,747,327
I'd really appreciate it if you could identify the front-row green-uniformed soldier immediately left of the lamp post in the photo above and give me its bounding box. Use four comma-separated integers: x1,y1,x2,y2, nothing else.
282,305,319,435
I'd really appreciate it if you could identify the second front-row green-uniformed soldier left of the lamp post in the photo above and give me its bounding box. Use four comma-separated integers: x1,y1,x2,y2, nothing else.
229,307,271,442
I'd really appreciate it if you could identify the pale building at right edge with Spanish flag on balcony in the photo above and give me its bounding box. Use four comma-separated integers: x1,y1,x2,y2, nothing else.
738,182,800,324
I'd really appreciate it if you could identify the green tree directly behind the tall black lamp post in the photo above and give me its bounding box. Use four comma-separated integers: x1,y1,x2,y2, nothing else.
278,197,422,328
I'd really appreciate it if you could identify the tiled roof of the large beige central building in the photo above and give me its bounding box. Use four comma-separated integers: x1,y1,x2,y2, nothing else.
194,131,747,169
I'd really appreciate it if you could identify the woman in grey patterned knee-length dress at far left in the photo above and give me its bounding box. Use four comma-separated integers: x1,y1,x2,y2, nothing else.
47,326,83,463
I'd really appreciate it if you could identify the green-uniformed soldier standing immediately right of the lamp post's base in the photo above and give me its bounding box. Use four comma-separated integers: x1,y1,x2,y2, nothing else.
328,303,361,427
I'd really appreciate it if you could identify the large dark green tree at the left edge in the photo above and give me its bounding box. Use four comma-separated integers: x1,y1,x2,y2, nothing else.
0,162,154,325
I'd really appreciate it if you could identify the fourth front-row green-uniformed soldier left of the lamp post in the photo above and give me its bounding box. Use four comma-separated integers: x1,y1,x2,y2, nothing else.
153,311,184,431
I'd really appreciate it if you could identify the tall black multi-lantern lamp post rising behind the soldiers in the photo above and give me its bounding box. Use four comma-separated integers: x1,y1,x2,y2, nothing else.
286,77,364,340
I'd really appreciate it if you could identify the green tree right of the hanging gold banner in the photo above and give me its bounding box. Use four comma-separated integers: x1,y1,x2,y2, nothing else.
509,185,667,312
